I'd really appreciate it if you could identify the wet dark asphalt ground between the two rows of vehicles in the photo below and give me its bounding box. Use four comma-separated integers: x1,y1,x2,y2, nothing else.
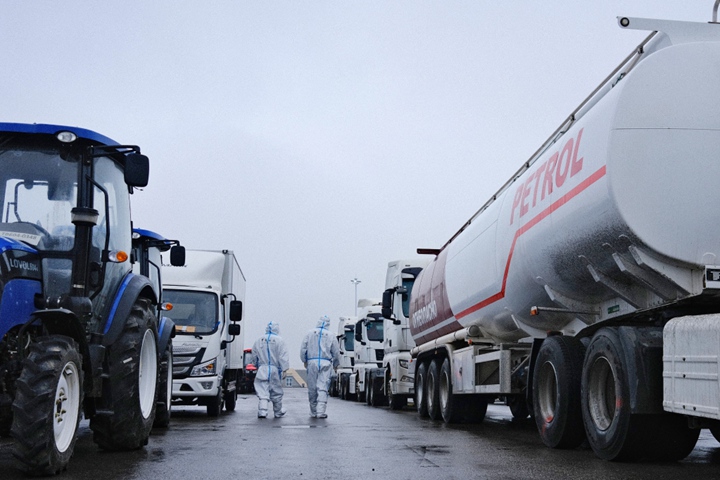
0,389,720,480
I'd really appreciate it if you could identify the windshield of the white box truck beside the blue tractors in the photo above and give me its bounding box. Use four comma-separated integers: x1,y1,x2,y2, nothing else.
163,289,219,335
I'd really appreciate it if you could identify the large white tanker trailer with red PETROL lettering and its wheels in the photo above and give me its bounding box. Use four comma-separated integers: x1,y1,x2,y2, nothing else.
410,10,720,460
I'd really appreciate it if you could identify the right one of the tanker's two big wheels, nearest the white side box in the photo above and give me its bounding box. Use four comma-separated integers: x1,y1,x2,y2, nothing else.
582,328,650,461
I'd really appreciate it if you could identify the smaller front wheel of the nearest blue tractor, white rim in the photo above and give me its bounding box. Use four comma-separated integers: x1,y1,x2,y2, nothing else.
11,335,83,475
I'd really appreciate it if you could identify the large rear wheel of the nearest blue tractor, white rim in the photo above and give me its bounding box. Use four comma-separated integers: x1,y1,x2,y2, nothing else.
90,298,158,450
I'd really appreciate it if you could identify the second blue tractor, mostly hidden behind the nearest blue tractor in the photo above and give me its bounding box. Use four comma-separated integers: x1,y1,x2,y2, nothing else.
132,228,185,428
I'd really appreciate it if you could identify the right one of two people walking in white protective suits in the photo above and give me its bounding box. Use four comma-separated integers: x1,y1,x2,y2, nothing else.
300,316,340,418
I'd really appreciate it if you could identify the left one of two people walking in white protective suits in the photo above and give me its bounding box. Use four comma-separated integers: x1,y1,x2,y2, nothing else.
252,322,290,418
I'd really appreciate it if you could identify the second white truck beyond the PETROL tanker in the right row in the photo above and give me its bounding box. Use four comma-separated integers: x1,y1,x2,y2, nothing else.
348,299,385,405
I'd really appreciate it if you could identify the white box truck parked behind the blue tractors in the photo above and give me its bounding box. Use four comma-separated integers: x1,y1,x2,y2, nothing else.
162,250,245,417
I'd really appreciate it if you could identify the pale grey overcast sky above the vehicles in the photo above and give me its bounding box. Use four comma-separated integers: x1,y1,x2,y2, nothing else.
0,0,714,367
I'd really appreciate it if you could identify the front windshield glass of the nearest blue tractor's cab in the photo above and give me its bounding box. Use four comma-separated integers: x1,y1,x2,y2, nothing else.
0,148,79,251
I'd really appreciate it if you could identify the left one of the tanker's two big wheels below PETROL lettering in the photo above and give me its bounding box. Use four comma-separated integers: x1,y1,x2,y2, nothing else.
533,336,585,449
